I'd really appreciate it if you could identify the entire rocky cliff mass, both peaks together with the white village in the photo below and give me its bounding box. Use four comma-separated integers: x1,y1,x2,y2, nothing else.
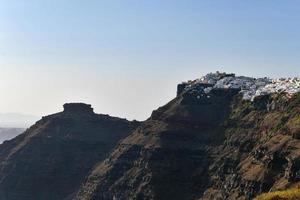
0,73,300,200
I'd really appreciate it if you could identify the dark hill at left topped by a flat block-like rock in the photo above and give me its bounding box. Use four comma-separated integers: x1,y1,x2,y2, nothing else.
0,103,139,200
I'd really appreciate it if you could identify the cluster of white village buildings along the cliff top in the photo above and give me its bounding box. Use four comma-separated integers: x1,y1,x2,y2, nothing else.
182,72,300,100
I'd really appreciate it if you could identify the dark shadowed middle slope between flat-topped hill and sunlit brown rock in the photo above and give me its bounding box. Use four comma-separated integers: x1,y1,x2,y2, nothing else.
77,89,238,200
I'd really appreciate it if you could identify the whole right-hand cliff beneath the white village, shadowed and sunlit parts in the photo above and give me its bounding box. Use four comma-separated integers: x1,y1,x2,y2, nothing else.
75,88,300,200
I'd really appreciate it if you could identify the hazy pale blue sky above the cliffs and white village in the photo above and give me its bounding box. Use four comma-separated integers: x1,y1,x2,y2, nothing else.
0,0,300,120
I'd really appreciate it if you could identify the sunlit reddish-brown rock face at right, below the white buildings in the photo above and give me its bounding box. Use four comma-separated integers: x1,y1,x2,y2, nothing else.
202,94,300,200
